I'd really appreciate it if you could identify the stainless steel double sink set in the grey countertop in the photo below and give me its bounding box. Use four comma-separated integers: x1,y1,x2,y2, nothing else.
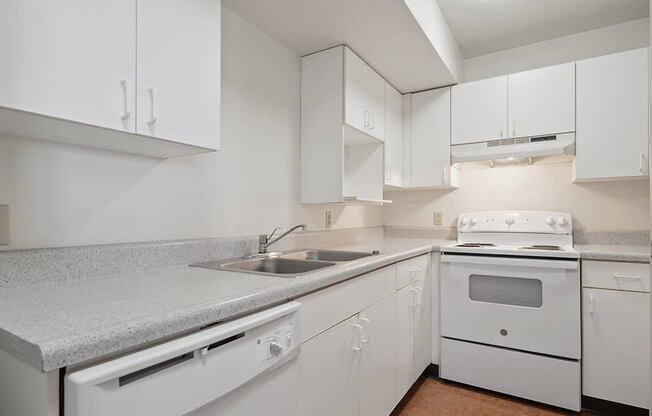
192,250,379,277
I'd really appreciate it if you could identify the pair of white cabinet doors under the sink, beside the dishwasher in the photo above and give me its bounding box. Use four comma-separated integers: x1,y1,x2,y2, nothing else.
299,293,396,416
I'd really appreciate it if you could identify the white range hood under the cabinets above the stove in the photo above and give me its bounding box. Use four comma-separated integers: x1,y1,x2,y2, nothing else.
451,133,575,163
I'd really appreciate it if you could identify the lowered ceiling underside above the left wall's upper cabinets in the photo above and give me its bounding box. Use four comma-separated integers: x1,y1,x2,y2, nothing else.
223,0,456,93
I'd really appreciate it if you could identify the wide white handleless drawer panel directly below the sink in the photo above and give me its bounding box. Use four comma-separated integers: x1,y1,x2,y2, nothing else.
299,264,396,342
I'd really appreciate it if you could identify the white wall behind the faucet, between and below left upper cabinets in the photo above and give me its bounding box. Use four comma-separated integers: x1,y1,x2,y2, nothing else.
0,9,382,248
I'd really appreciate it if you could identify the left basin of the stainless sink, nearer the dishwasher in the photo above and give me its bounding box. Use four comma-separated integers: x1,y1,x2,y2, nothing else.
196,257,335,276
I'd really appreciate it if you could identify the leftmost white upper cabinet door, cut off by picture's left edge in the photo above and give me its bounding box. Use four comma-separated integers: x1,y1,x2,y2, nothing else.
0,0,136,132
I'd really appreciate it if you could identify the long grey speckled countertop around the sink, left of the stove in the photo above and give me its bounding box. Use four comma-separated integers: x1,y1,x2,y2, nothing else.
0,238,450,371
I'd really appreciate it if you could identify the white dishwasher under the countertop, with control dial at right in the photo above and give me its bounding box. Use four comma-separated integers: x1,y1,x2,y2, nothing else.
64,302,300,416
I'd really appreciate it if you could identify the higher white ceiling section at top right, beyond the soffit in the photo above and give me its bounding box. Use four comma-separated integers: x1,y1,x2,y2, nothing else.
437,0,649,58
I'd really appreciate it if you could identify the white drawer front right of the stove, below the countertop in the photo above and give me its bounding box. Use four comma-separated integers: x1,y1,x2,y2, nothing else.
582,260,650,292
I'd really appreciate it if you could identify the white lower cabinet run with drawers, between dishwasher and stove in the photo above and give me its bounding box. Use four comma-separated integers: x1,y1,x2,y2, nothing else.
299,255,432,416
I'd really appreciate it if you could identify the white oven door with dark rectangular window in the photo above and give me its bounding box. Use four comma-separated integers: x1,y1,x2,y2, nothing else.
441,254,581,359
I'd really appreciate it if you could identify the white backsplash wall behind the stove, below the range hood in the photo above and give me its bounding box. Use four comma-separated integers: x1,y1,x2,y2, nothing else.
384,162,650,231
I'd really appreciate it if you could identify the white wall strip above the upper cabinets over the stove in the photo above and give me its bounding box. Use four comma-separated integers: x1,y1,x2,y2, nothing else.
464,18,650,82
